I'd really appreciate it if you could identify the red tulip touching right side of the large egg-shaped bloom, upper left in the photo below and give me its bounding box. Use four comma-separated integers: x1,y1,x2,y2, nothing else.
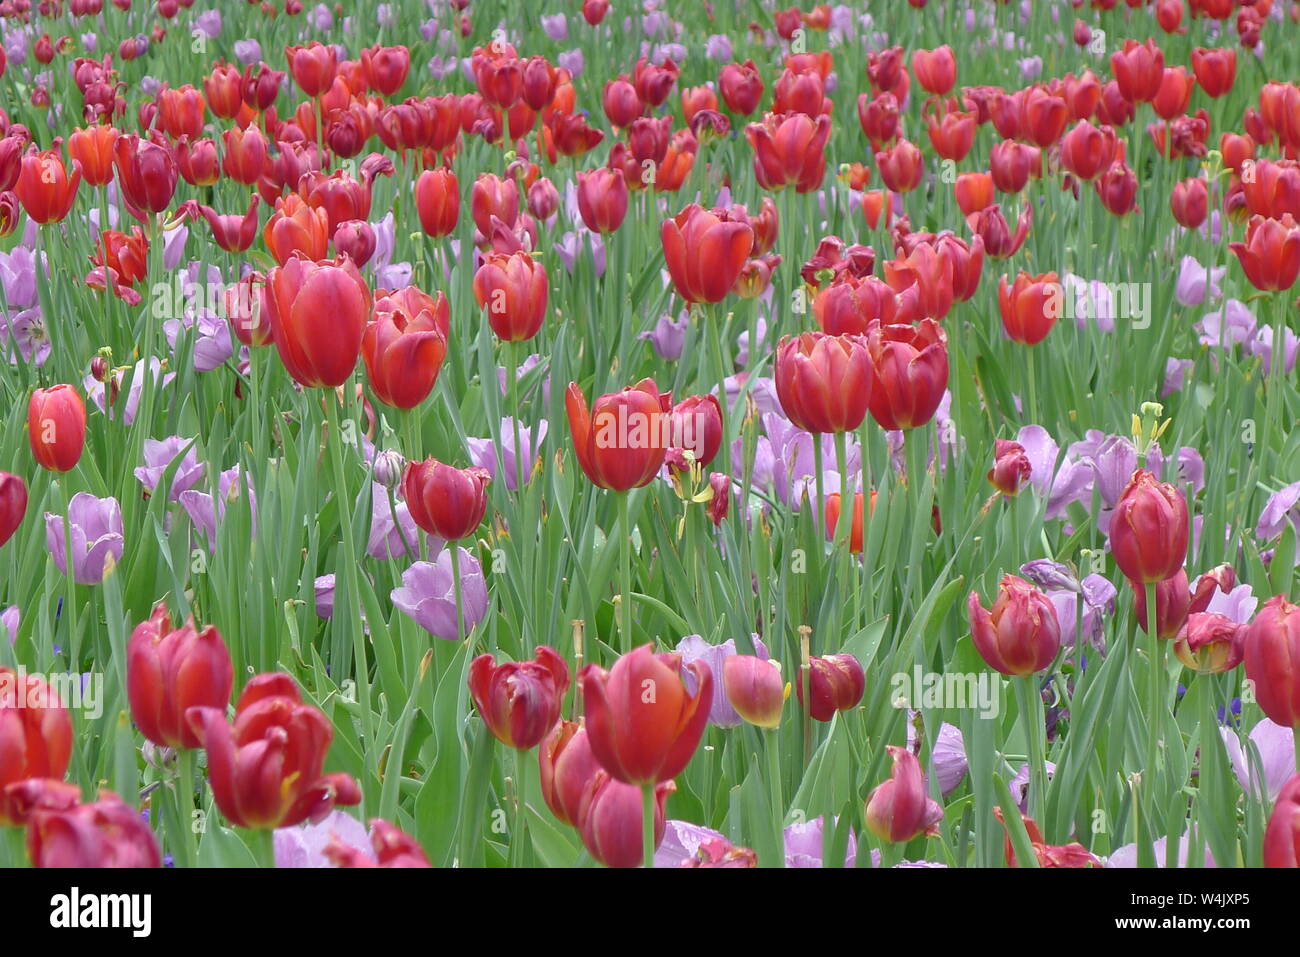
361,286,450,408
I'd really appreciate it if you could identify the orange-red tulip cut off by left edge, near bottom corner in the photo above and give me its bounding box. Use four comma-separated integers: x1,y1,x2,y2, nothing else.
0,665,73,827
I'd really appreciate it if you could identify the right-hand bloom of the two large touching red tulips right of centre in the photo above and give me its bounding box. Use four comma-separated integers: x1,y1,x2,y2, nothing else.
867,319,948,430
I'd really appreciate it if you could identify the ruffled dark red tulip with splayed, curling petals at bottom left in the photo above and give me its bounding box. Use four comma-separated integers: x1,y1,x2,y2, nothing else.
186,672,361,830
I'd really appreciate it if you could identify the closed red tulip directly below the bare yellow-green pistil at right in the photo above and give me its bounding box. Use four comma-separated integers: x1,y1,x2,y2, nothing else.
1110,469,1188,584
